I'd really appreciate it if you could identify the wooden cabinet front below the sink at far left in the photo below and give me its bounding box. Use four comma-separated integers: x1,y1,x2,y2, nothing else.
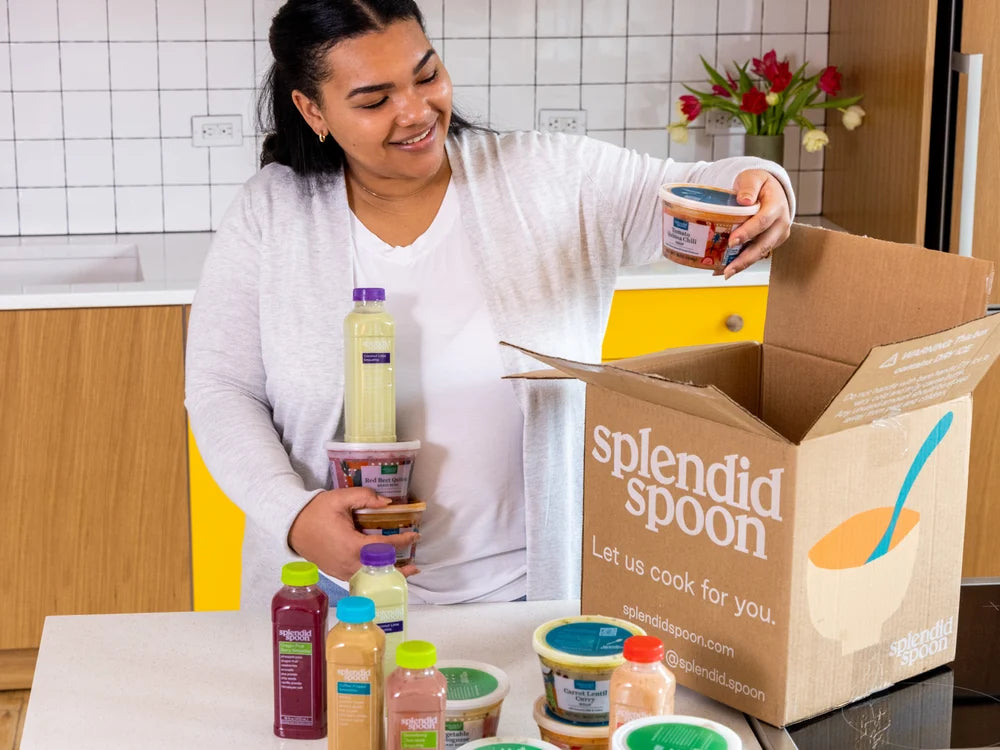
0,306,191,650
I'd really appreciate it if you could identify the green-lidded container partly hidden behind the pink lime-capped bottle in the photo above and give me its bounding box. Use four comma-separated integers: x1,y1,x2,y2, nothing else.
437,660,510,750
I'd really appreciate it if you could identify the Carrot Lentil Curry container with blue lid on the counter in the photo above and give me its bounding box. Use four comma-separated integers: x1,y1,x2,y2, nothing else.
532,615,646,724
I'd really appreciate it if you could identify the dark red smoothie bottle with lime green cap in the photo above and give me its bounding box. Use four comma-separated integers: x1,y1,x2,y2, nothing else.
271,562,329,740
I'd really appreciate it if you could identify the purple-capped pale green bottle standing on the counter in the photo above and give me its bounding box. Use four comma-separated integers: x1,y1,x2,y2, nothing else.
350,542,407,674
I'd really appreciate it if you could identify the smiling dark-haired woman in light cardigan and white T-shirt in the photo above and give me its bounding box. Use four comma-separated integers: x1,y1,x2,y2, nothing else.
187,0,791,607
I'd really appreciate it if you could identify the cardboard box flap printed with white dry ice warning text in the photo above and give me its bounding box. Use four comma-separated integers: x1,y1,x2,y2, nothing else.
804,315,1000,440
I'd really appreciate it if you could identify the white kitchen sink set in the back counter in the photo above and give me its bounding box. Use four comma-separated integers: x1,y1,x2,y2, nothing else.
0,244,143,286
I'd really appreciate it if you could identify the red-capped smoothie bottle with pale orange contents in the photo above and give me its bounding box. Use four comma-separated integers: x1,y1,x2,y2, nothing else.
608,635,677,732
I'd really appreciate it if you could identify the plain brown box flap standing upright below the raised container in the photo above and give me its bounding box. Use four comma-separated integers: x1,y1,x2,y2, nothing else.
764,224,993,365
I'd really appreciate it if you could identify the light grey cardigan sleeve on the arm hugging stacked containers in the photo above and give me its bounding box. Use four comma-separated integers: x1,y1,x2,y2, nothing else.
185,181,320,545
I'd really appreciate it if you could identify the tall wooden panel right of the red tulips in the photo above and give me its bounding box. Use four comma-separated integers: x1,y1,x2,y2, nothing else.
823,0,937,243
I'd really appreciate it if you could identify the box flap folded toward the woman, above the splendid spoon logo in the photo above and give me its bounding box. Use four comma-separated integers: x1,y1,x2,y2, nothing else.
500,341,789,443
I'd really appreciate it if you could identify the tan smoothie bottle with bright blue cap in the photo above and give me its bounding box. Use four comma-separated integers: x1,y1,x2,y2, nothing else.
326,596,385,750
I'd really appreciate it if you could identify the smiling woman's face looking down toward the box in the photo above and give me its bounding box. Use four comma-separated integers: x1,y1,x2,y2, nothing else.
303,20,452,185
